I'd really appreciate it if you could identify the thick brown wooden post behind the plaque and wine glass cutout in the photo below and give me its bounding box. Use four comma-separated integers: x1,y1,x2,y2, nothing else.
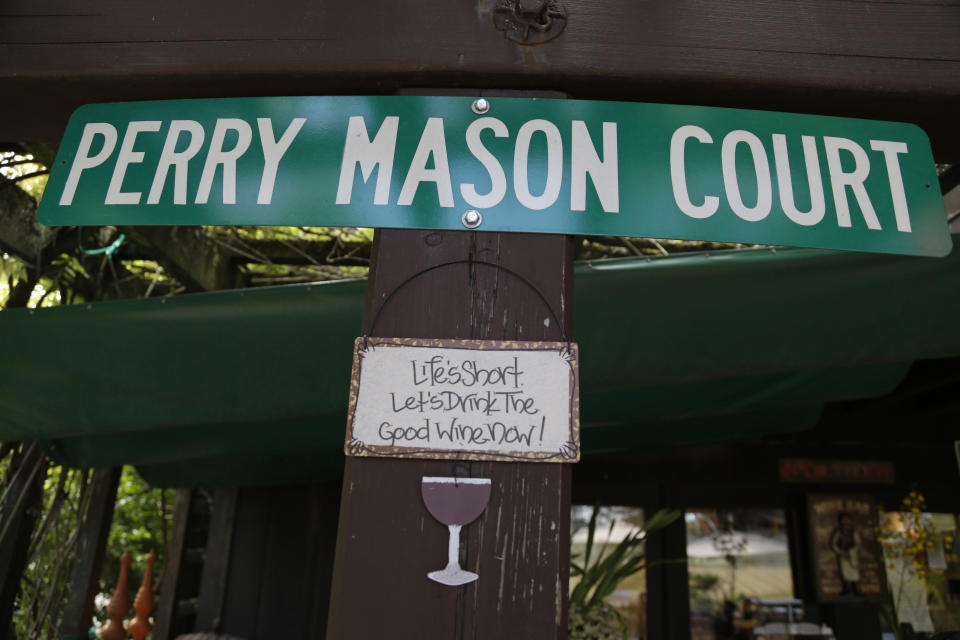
328,230,573,640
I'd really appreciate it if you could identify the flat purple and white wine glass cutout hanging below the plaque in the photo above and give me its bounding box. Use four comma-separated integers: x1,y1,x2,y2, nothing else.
420,476,490,587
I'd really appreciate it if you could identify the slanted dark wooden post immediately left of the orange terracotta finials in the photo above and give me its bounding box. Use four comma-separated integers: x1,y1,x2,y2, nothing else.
60,467,122,638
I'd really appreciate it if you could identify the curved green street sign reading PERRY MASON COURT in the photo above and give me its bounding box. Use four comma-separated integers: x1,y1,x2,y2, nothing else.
39,96,951,256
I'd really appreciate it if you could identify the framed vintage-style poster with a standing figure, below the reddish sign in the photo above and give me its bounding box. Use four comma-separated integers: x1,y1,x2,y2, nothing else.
807,494,886,602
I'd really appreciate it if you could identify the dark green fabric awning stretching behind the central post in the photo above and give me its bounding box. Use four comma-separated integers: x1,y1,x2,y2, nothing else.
0,239,960,485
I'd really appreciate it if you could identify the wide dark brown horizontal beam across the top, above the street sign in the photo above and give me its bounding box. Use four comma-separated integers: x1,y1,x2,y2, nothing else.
0,0,960,161
